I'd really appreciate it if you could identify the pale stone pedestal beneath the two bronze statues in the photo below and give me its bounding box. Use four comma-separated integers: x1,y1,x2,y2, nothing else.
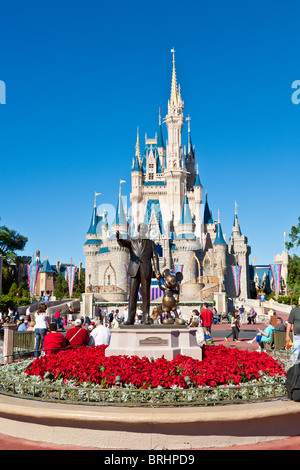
105,325,202,361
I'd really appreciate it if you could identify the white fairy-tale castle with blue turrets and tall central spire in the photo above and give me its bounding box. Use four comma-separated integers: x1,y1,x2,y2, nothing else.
84,49,251,302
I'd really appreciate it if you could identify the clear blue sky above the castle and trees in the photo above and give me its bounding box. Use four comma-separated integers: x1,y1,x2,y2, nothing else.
0,0,300,264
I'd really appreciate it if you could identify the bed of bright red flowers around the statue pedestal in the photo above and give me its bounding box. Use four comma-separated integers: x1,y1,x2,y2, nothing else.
25,346,285,389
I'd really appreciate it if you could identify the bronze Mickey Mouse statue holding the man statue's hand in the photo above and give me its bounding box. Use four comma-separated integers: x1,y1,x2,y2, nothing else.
157,269,185,325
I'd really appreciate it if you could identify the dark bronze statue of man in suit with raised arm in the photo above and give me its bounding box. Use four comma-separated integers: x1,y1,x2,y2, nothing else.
116,224,161,325
